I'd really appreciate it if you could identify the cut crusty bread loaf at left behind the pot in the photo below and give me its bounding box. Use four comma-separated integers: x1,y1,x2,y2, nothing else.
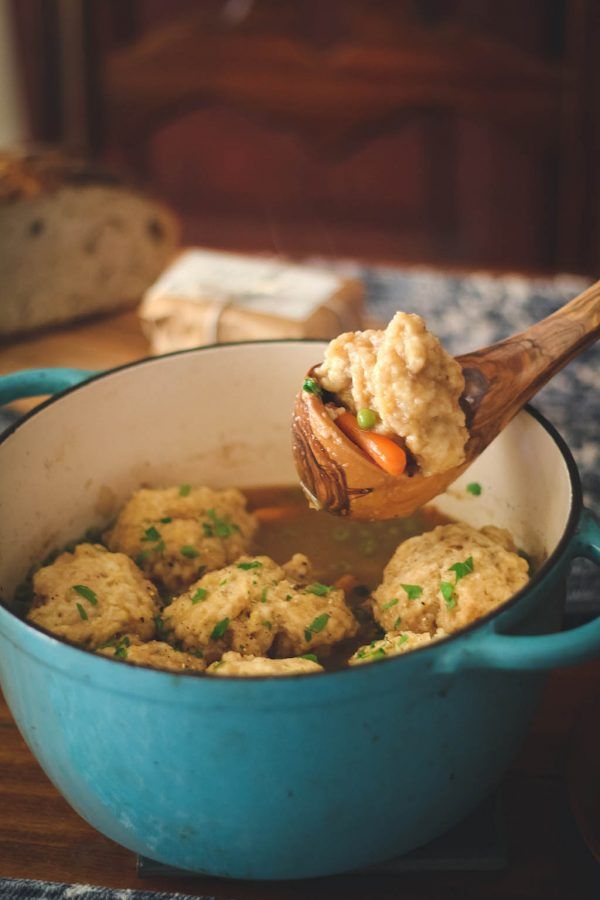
0,152,179,337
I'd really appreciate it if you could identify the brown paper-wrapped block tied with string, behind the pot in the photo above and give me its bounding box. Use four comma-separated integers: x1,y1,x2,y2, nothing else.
139,248,364,354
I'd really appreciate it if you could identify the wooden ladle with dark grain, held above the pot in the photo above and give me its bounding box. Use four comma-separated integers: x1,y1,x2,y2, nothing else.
292,281,600,519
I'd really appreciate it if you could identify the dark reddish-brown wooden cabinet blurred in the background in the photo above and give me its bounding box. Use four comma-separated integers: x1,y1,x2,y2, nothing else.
10,0,600,273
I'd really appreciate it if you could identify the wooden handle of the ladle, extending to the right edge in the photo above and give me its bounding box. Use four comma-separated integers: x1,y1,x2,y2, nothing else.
457,281,600,457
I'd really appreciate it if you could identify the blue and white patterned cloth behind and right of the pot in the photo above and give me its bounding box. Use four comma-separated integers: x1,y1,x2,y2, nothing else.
0,260,600,612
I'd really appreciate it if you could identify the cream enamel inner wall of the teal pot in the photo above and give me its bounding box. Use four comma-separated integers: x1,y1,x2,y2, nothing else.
0,341,572,598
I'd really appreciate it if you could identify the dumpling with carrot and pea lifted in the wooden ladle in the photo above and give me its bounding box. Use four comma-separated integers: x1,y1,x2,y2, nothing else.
312,312,469,476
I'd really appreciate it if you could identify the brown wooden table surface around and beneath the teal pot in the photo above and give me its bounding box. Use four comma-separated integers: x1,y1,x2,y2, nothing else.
0,313,600,900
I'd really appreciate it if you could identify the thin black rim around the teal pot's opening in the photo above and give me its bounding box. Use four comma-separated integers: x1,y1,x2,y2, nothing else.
0,338,583,684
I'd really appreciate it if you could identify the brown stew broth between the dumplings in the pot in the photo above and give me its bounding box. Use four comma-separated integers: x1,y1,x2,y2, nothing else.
242,487,452,669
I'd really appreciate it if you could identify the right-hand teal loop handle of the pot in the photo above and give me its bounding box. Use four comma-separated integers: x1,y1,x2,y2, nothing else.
436,509,600,673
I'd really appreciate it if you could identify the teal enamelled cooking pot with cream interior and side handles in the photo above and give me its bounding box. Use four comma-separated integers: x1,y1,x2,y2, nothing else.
0,341,600,878
